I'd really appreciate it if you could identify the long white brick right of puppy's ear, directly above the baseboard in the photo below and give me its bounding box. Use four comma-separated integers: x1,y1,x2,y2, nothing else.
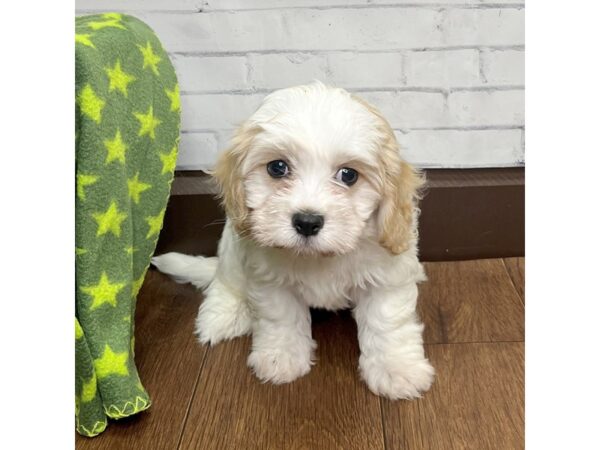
396,129,523,168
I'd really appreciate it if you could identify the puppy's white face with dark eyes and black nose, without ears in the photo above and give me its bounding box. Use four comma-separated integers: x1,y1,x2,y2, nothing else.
242,121,381,254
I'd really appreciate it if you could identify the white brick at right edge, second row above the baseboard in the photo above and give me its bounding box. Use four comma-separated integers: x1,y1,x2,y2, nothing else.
448,90,525,127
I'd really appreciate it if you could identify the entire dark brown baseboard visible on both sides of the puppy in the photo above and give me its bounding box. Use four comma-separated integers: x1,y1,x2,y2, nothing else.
156,167,525,261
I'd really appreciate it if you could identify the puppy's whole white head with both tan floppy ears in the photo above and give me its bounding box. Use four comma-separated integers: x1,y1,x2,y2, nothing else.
215,82,422,255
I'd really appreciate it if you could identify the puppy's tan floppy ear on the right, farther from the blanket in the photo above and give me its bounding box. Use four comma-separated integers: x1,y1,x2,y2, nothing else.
355,97,425,255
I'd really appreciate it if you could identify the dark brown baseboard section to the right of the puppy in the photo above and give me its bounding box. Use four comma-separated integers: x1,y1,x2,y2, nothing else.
419,168,525,261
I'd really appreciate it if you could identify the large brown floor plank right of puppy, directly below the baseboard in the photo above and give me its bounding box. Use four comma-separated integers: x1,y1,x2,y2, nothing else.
418,259,524,344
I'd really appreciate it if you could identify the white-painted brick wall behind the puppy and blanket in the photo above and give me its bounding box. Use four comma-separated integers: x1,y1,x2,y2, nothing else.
77,0,525,169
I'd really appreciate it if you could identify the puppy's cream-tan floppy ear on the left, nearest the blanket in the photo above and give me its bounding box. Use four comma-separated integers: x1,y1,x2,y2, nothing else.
212,124,258,234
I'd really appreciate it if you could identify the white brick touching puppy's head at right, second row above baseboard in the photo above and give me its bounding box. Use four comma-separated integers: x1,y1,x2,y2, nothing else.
358,91,447,129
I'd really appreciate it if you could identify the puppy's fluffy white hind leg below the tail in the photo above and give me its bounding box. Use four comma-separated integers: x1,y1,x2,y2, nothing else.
196,277,252,345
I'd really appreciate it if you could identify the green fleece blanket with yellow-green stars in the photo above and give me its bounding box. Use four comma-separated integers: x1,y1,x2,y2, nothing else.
75,13,180,436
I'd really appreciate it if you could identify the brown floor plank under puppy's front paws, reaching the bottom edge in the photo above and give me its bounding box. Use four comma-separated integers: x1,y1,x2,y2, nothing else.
180,313,384,450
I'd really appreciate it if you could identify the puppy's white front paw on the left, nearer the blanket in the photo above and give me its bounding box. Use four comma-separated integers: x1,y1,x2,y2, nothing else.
248,344,313,384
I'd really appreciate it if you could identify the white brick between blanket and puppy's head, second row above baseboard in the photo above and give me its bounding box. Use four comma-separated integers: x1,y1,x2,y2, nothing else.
181,94,265,131
